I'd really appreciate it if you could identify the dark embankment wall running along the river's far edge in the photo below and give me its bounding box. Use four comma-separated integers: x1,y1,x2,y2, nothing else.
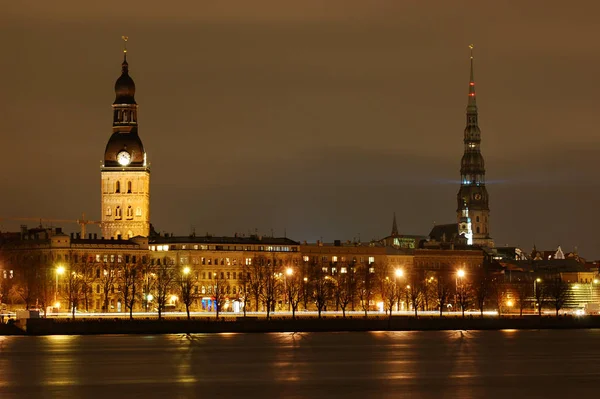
0,316,600,335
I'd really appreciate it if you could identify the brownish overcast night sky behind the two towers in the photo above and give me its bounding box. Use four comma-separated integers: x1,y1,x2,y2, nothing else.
0,0,600,258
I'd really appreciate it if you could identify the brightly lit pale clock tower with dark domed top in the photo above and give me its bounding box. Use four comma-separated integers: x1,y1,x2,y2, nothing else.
101,37,150,239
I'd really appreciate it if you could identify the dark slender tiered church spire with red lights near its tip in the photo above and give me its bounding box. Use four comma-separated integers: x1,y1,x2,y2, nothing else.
456,45,494,247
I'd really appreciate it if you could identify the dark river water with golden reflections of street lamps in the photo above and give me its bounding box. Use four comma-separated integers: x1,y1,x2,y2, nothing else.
0,330,600,399
